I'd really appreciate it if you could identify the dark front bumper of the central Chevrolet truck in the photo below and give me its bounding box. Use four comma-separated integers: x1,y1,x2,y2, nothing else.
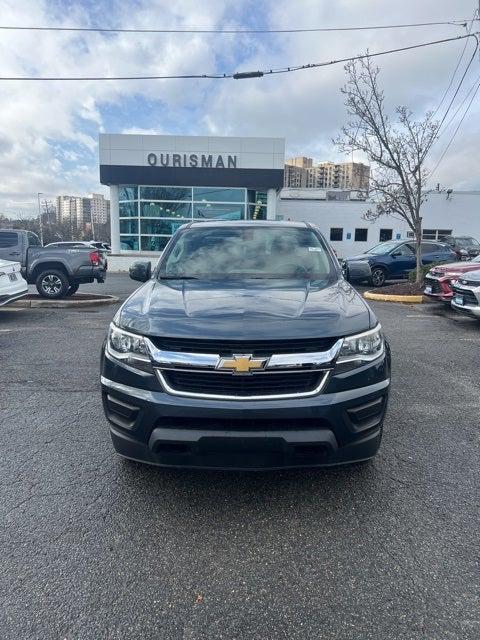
102,349,390,470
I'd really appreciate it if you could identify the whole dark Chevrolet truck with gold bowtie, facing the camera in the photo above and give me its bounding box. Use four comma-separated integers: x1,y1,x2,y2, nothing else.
101,221,390,469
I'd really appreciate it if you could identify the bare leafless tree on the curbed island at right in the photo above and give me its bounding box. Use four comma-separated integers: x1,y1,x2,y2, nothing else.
334,57,439,282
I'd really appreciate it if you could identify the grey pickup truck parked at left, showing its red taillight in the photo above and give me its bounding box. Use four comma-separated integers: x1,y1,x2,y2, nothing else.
0,229,107,298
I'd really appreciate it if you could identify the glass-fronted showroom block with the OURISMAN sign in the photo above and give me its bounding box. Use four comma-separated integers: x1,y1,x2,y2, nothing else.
99,134,285,254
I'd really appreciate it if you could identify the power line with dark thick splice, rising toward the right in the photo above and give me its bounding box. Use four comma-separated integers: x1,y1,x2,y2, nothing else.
0,33,477,81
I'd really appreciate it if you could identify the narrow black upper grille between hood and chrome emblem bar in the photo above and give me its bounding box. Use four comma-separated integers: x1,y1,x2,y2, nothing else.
149,336,338,357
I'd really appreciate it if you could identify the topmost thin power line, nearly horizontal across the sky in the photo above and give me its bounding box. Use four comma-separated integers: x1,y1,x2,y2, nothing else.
0,18,469,35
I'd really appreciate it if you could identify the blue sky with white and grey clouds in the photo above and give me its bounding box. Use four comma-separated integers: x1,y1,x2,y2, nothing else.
0,0,480,215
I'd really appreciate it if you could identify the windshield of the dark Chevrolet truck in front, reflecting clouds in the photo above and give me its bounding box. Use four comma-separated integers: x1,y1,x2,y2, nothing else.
158,225,337,281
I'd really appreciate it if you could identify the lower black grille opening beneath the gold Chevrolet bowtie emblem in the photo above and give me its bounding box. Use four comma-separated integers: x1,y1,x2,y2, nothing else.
162,369,325,396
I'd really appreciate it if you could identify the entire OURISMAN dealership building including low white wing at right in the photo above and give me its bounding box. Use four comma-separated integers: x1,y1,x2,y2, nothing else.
100,134,480,260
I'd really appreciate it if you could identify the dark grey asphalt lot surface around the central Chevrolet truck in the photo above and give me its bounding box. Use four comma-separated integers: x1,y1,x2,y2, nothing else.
0,274,480,640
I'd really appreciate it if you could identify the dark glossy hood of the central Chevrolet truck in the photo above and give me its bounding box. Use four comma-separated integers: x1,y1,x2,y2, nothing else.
116,280,377,340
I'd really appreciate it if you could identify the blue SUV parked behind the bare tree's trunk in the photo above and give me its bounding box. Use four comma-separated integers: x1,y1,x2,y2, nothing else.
346,240,456,287
